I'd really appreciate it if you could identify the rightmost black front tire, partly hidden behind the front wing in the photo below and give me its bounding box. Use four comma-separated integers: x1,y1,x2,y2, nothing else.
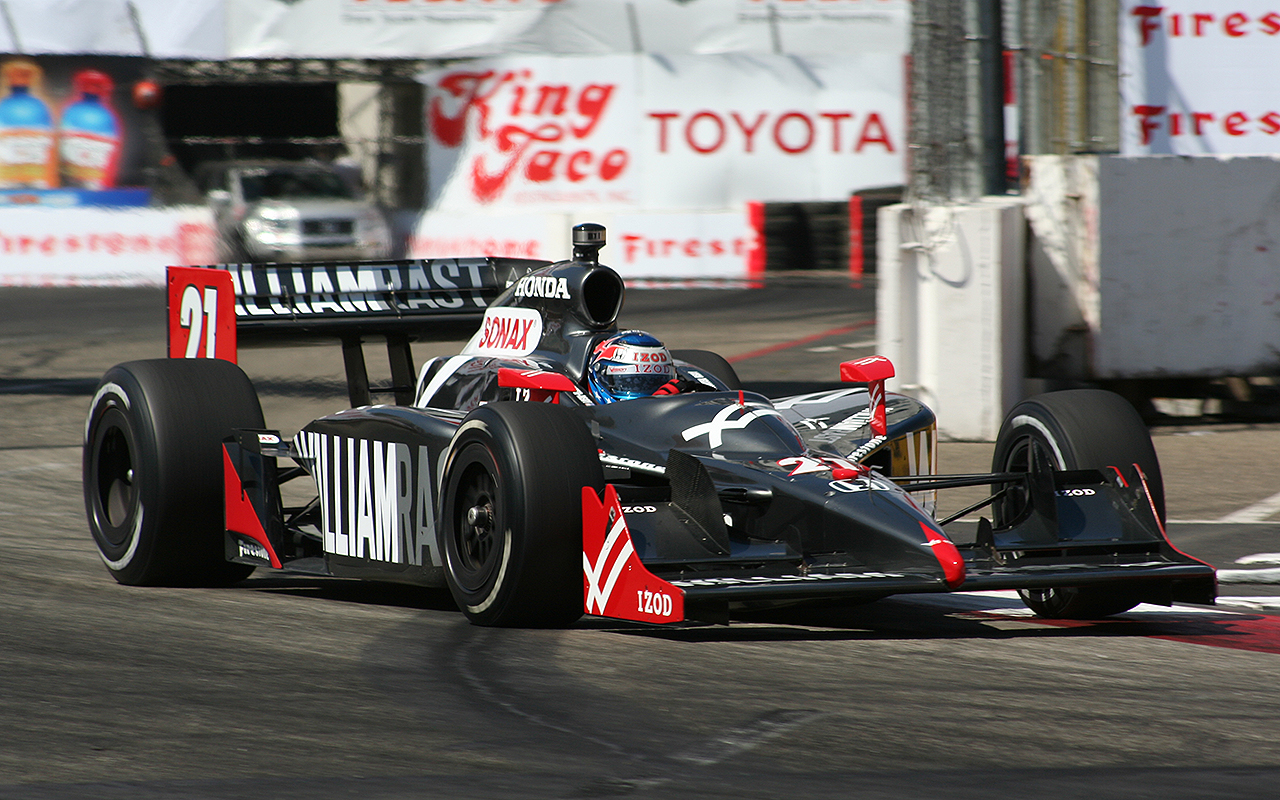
991,389,1165,620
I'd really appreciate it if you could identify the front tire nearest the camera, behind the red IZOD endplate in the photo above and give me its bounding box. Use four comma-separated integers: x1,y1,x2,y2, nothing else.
440,402,604,627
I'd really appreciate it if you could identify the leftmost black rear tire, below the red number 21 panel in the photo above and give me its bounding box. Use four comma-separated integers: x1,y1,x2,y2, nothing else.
83,358,262,586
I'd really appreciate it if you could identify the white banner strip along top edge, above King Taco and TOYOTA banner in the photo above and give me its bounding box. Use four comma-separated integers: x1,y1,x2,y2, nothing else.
225,0,910,58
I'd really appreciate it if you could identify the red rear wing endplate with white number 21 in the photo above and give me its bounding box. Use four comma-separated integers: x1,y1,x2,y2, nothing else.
166,266,236,364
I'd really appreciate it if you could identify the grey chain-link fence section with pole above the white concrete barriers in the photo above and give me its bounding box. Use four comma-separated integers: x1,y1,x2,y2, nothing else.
908,0,1120,202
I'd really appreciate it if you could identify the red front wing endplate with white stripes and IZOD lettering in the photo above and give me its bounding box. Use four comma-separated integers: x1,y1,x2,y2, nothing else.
582,485,685,623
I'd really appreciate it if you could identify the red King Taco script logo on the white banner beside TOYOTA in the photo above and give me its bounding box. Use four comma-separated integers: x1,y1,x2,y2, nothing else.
428,69,631,202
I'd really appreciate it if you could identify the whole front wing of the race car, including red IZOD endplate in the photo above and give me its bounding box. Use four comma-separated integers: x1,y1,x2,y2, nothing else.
582,458,1217,625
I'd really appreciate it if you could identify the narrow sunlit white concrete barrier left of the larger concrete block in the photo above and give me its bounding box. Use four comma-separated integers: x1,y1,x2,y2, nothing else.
877,198,1024,442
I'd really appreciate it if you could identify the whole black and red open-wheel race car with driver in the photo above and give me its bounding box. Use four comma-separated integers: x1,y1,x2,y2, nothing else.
83,224,1216,626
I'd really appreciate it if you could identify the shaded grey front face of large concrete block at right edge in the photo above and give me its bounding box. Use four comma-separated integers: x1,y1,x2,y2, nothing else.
1093,156,1280,378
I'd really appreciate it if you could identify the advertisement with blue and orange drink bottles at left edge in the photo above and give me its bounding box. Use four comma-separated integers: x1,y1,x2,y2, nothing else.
0,56,151,207
